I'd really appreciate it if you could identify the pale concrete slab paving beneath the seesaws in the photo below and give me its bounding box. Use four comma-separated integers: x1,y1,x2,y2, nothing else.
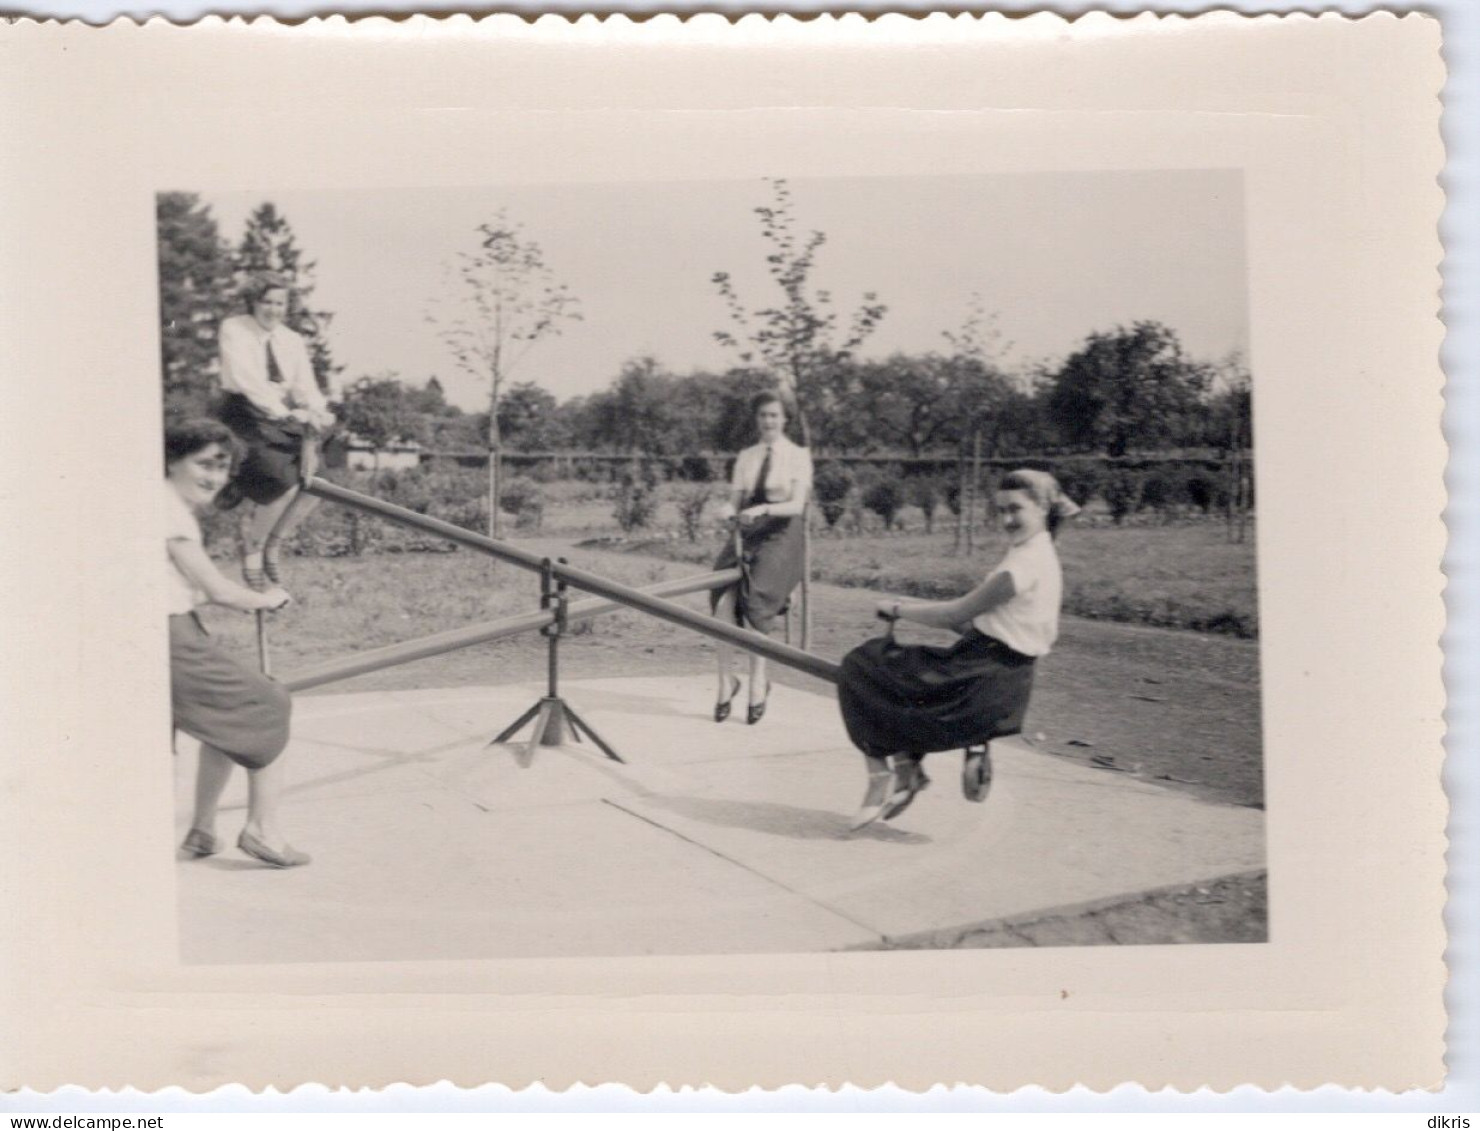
176,675,1264,962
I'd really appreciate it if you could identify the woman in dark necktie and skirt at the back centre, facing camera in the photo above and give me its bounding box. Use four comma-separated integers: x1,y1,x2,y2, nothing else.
710,392,813,724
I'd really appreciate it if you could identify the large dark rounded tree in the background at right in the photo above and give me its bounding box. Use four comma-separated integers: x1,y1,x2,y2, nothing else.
1048,321,1211,456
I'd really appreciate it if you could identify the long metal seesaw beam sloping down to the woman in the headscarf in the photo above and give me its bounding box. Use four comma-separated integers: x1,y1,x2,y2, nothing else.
303,477,838,682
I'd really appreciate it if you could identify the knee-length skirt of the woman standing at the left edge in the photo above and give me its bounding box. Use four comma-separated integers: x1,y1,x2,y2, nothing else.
170,613,293,770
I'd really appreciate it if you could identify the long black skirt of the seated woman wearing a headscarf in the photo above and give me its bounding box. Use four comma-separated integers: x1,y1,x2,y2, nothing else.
838,629,1033,756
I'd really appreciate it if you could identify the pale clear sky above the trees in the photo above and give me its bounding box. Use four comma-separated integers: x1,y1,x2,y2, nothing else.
203,170,1248,409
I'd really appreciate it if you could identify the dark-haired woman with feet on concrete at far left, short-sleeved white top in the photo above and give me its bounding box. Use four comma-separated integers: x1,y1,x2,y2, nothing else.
163,420,309,867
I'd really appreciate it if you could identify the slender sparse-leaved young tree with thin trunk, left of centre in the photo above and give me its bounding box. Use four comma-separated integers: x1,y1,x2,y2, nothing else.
428,217,582,537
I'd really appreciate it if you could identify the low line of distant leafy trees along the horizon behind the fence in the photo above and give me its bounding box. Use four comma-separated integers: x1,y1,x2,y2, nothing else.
324,323,1251,459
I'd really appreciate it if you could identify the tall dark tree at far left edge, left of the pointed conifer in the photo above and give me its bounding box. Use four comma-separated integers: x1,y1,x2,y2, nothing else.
154,192,231,417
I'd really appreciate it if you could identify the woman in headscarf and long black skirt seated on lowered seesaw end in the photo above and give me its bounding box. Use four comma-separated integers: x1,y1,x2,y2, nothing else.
838,471,1079,830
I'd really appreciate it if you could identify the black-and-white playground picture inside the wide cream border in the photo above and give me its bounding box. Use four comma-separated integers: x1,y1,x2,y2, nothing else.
155,169,1268,964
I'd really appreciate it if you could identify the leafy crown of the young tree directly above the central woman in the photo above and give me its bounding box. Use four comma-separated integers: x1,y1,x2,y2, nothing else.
712,179,888,446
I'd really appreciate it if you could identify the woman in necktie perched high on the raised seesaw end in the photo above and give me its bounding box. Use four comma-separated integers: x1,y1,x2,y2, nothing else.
216,274,334,591
